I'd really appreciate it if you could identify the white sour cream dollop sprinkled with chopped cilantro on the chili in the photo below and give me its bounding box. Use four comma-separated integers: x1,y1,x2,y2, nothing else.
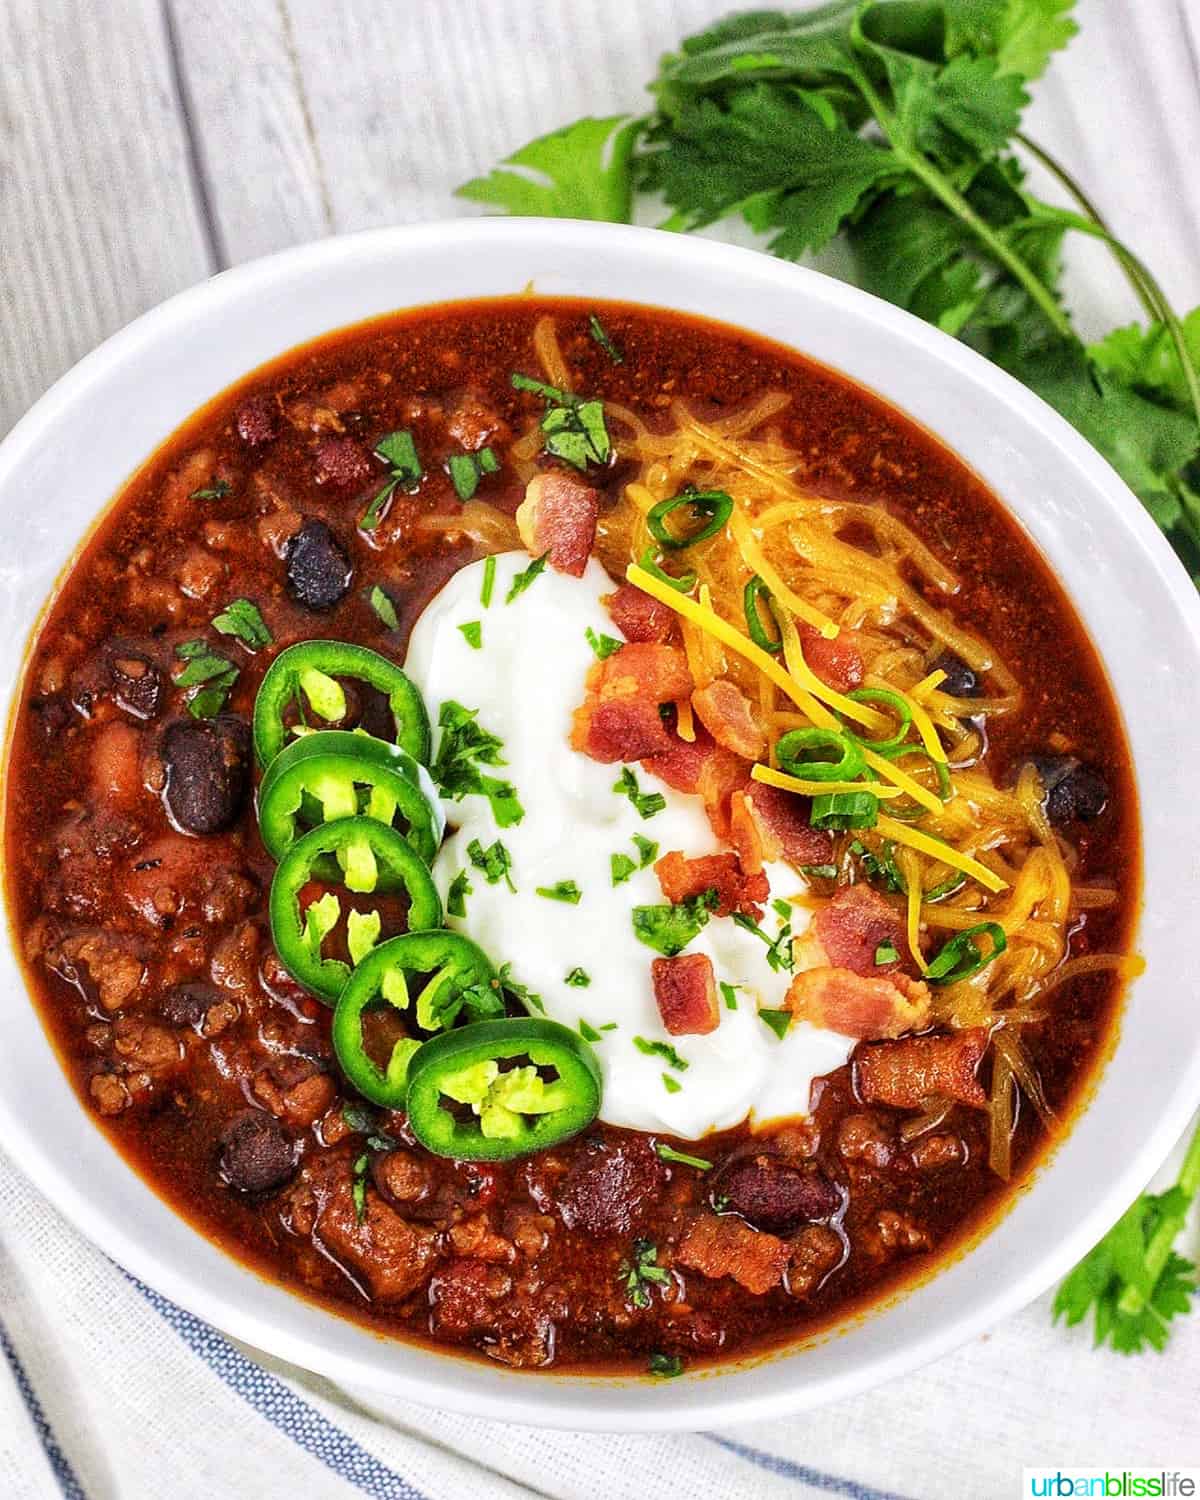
407,552,852,1139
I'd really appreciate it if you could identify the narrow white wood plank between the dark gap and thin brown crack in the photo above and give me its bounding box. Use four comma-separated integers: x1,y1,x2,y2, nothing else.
167,0,336,264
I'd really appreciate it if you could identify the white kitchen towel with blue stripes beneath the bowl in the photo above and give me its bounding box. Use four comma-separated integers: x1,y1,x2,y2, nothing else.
0,1142,1200,1500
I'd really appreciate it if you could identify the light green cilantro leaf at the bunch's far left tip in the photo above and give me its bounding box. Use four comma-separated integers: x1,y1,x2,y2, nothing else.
458,114,642,224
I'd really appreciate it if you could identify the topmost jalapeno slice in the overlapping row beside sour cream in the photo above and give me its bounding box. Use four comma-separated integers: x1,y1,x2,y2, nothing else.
254,641,429,767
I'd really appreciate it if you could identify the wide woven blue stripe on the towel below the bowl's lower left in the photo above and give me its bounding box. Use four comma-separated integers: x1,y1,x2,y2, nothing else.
126,1272,425,1500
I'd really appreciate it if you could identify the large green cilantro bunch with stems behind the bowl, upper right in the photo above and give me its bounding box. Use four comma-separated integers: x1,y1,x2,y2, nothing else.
459,0,1200,582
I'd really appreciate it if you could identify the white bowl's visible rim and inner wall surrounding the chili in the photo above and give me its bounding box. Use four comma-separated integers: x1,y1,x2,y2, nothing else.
0,219,1200,1430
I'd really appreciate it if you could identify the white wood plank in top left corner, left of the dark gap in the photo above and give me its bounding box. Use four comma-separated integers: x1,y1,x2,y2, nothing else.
0,0,212,434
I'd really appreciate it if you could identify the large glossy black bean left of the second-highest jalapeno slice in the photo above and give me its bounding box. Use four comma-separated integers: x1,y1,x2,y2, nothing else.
161,714,251,834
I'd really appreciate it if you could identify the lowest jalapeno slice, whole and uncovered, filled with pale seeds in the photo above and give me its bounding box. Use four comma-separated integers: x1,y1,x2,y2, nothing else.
408,1017,600,1161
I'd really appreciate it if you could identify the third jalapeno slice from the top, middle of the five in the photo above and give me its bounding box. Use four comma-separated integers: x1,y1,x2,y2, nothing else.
269,818,441,1004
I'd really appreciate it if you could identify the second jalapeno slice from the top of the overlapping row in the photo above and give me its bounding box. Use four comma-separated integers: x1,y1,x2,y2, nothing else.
258,729,446,864
